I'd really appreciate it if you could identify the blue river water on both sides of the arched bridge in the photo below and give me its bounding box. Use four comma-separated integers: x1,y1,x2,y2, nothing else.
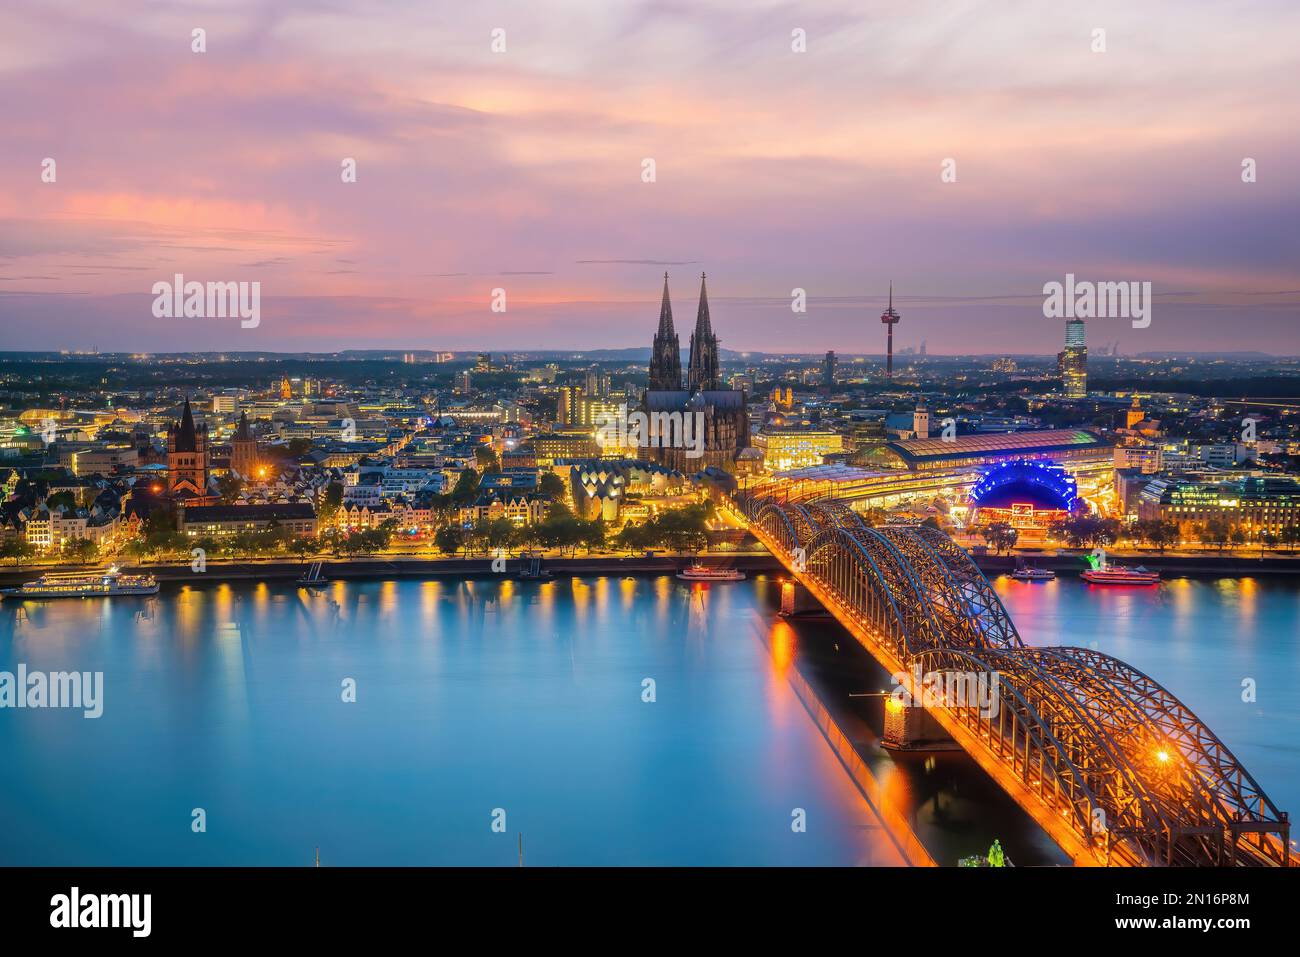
0,576,1300,866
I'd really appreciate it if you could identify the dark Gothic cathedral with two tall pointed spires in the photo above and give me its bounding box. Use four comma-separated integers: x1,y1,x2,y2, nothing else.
638,273,749,473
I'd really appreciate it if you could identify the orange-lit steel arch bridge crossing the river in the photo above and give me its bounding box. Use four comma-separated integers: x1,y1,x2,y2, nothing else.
733,494,1291,866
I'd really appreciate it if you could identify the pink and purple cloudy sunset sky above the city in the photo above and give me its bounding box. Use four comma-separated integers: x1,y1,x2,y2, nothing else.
0,0,1300,355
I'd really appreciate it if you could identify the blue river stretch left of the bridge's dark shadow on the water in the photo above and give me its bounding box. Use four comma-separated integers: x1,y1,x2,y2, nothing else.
0,577,897,865
